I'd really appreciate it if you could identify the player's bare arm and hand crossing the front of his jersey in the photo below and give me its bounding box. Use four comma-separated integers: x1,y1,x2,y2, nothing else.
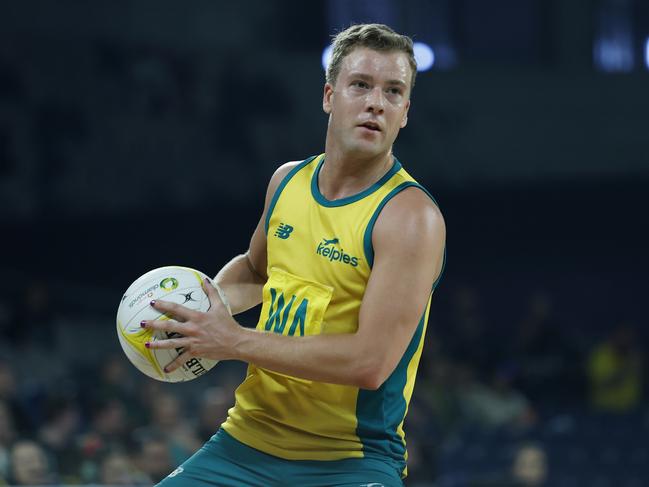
147,189,445,389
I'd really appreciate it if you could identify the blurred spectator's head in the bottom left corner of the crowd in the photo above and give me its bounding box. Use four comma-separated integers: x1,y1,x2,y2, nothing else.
9,440,57,485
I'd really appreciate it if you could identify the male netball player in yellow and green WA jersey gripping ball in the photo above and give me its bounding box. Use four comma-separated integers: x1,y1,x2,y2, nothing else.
142,24,445,487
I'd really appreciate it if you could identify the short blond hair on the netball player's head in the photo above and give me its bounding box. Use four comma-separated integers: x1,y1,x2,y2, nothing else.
327,24,417,90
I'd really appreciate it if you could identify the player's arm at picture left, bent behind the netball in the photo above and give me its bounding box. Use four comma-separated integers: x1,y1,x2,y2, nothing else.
214,161,299,315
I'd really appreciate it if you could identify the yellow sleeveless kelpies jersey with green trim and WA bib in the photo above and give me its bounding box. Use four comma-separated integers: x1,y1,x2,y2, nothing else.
223,154,439,475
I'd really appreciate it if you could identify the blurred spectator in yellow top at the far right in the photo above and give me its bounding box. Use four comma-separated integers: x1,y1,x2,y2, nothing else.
587,324,644,413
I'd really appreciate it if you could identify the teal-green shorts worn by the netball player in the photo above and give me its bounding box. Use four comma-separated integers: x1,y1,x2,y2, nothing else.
157,429,403,487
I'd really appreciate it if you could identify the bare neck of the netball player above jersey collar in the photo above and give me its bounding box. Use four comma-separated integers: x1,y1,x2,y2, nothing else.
318,145,394,201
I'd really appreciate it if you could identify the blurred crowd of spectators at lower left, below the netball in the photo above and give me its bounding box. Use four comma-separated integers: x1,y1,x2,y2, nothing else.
0,356,243,485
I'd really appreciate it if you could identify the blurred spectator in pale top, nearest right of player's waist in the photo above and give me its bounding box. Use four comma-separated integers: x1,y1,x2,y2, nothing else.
459,365,536,430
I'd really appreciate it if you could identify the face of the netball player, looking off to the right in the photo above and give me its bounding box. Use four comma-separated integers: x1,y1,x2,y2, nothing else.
322,48,412,157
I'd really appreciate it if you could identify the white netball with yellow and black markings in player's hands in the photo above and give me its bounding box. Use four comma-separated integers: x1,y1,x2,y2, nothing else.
117,266,217,382
